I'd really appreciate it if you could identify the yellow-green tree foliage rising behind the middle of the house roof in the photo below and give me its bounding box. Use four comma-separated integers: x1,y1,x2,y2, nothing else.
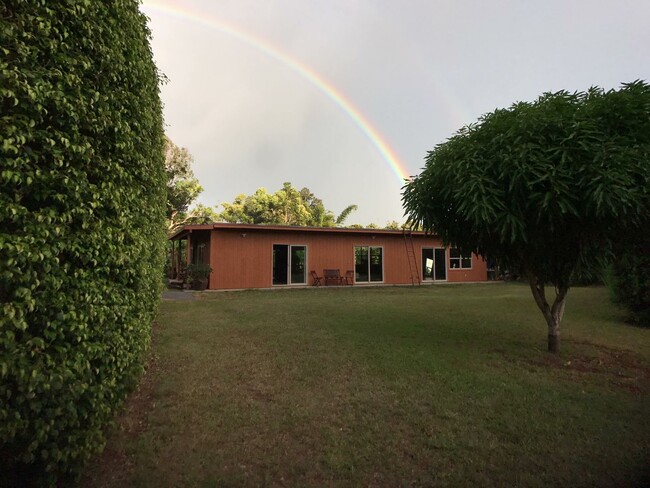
219,182,357,227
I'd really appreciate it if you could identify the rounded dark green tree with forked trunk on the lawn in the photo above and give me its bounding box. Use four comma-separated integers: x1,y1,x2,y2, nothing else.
402,81,650,351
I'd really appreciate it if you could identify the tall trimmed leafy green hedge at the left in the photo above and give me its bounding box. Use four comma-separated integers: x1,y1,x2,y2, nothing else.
0,0,165,484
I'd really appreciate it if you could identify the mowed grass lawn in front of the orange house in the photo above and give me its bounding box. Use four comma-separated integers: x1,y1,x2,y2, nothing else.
82,283,650,487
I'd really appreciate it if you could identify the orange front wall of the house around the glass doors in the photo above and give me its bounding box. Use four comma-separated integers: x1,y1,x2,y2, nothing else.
209,228,487,289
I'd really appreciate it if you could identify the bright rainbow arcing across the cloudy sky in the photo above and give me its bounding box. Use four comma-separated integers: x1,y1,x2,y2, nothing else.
142,0,411,184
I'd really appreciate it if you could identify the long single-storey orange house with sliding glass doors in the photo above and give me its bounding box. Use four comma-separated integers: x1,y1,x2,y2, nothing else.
170,223,487,290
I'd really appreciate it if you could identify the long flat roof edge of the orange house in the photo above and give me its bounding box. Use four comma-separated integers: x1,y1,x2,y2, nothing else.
169,222,435,241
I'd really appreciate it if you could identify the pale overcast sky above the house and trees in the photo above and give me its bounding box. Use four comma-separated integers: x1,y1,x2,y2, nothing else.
142,0,650,225
